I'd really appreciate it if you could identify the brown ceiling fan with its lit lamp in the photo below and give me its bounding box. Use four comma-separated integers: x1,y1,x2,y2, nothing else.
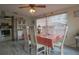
19,4,46,13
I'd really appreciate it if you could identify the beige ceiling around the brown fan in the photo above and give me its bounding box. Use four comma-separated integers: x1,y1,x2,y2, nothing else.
0,4,76,17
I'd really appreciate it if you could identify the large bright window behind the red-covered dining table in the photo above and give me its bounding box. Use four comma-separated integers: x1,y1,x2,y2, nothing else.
37,13,67,35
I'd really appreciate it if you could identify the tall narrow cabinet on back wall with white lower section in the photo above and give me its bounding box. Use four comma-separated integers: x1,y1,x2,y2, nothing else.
17,18,26,40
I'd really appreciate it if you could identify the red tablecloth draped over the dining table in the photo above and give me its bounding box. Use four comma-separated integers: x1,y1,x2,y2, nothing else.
37,35,63,47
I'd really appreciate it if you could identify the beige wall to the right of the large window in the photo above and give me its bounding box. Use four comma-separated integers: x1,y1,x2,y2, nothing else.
65,6,79,47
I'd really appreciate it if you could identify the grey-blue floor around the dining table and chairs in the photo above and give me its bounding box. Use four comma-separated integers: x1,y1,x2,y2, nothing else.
0,41,79,55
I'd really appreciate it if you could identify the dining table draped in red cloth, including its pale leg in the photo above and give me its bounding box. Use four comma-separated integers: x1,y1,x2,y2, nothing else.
36,34,64,54
